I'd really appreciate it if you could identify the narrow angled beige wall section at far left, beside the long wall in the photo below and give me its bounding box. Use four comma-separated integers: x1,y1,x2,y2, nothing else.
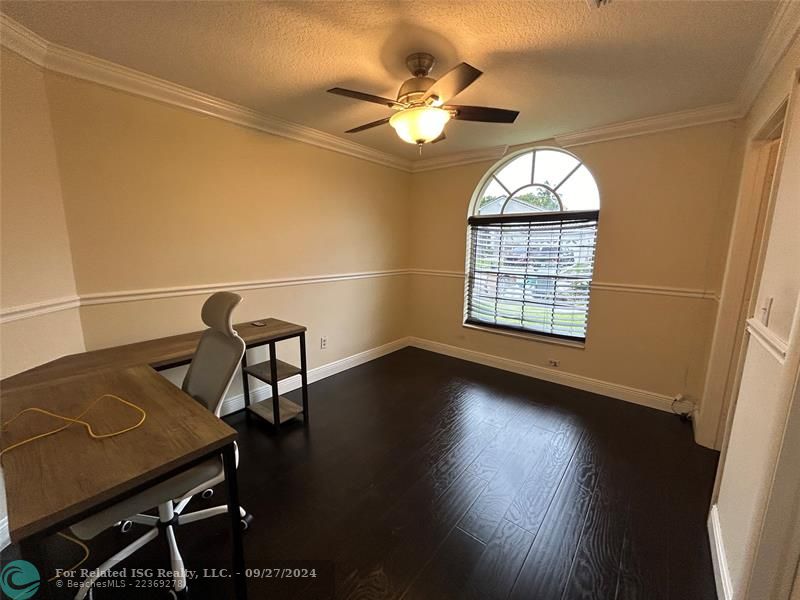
0,49,84,376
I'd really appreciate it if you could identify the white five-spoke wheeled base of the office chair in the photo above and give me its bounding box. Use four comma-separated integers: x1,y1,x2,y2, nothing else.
75,498,253,600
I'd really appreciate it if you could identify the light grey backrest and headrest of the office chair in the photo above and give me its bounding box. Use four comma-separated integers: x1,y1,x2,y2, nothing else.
181,292,245,416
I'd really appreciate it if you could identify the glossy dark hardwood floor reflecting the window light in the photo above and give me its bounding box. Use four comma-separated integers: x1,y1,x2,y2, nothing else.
5,348,717,600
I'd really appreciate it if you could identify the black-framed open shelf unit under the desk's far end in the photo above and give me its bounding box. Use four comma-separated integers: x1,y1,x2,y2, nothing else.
242,321,308,428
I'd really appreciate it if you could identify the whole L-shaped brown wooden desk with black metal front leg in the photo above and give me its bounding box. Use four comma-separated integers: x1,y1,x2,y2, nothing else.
0,319,306,600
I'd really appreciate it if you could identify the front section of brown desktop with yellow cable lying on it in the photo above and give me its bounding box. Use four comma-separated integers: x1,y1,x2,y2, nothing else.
2,366,236,542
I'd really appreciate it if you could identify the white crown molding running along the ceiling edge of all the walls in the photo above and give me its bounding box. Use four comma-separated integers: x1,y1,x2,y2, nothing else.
0,6,800,173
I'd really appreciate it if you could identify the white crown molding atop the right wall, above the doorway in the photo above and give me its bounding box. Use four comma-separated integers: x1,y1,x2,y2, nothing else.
737,0,800,114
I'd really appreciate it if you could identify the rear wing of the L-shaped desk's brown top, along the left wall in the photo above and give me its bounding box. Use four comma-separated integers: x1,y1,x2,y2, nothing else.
0,318,306,392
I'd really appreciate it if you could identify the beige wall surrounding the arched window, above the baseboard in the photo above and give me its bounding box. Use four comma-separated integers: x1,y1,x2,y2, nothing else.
410,123,739,410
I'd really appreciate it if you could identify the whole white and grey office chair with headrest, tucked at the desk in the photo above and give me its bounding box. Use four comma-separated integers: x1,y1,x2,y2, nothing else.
70,292,252,600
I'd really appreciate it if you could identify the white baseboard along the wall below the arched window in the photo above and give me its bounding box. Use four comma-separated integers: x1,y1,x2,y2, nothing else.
408,337,672,412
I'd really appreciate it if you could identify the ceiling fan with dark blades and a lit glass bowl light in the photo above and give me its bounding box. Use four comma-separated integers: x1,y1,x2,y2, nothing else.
328,52,519,146
